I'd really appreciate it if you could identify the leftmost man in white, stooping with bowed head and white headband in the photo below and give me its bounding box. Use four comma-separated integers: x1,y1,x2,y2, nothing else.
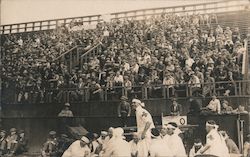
62,136,90,157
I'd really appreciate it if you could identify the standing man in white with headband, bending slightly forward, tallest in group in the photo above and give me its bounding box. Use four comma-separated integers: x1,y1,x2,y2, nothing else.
132,99,155,156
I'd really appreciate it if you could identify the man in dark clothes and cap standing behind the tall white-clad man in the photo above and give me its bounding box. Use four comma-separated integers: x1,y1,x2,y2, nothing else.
117,96,131,127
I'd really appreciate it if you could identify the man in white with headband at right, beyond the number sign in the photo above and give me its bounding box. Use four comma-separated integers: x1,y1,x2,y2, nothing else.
199,120,229,157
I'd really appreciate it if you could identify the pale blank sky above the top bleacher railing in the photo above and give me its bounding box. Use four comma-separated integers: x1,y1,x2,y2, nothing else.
0,0,219,25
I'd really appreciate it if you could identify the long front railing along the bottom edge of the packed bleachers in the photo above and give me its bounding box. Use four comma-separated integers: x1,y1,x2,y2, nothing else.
2,80,250,104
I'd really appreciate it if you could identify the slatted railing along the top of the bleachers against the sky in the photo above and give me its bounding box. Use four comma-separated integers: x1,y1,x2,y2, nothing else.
0,0,250,34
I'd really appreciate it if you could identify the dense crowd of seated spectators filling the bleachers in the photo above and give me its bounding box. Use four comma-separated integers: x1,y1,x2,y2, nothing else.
1,14,245,102
